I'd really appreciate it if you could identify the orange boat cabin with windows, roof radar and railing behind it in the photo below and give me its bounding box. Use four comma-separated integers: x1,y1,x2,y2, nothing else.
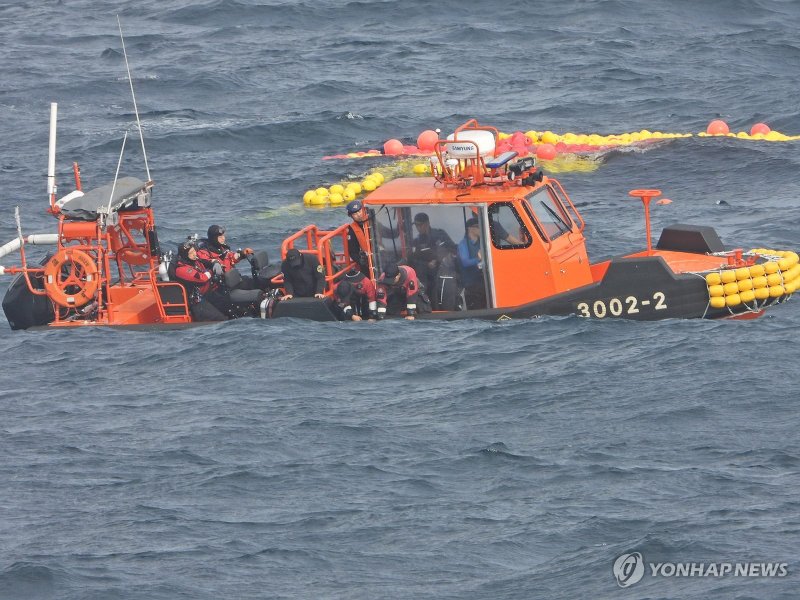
283,121,592,311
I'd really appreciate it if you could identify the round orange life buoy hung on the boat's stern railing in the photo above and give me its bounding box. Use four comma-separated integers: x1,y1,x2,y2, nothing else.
44,248,100,308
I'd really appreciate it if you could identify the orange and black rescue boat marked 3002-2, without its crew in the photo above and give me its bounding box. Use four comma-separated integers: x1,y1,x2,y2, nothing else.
0,116,800,329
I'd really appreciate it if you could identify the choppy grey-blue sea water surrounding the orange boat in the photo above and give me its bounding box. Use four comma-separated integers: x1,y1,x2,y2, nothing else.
0,0,800,600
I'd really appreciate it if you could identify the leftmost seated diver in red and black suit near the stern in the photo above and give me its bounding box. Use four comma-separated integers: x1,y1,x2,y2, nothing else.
175,240,228,321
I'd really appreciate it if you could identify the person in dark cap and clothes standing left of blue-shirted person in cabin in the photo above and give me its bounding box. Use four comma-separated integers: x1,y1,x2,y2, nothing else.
408,212,456,308
